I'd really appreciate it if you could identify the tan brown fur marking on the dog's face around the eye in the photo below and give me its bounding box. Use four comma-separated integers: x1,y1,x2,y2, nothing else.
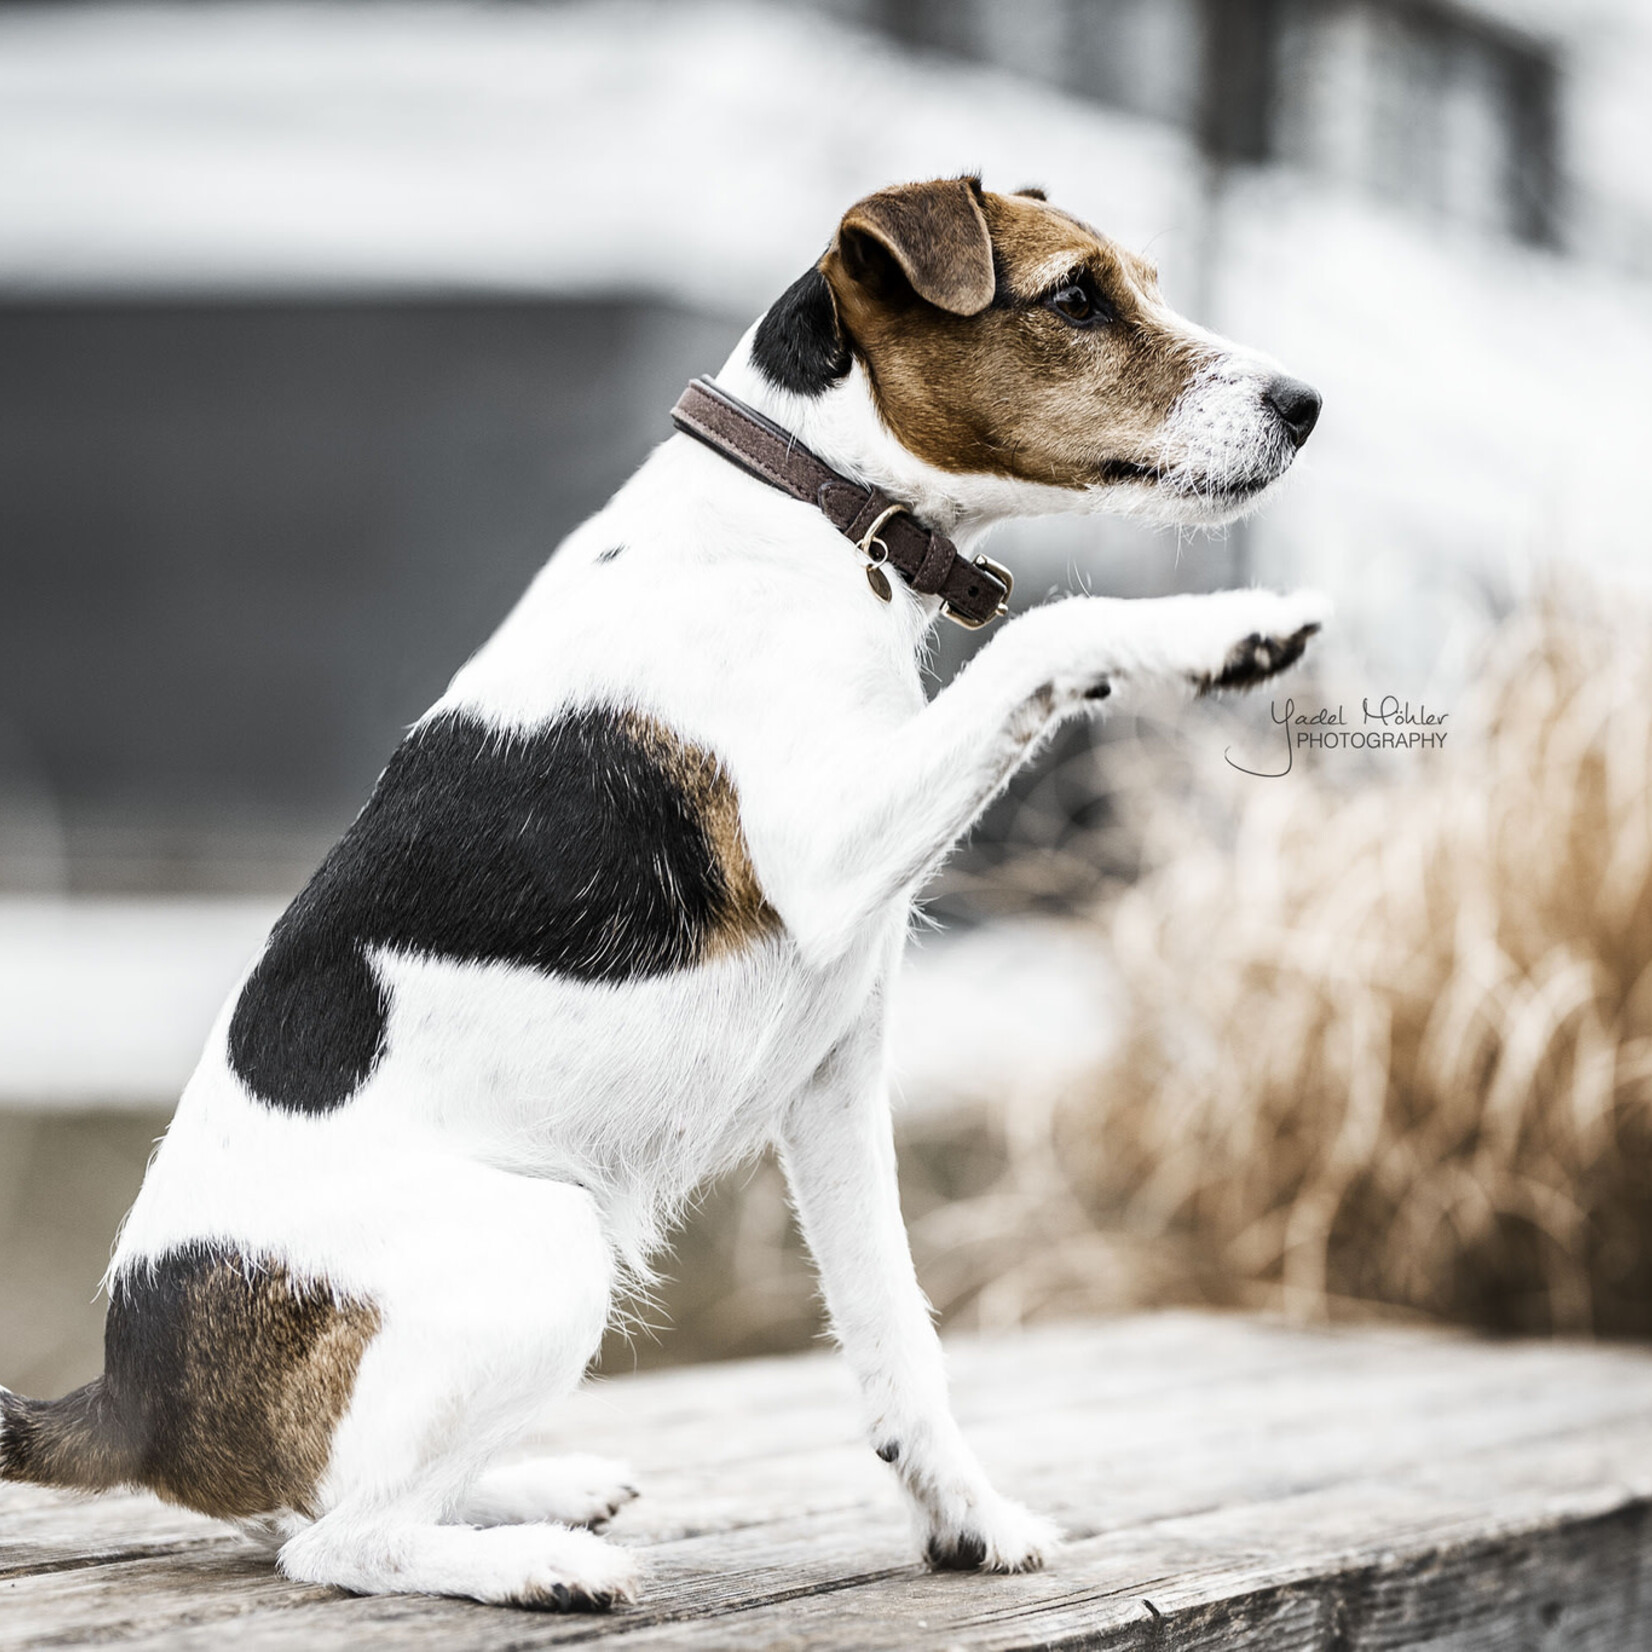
821,180,1208,489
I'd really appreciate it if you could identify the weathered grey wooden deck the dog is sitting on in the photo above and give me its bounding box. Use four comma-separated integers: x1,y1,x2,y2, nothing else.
0,1313,1652,1652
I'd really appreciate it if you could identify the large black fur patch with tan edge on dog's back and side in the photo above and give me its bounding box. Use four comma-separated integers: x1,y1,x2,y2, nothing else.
230,707,767,1113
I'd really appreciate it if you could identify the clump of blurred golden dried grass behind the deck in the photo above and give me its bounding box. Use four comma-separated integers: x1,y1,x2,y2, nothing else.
997,601,1652,1335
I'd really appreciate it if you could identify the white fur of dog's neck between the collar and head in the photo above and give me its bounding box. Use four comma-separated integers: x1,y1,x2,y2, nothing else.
717,327,997,553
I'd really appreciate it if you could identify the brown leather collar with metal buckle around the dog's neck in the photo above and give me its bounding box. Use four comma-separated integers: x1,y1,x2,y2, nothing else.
671,378,1014,631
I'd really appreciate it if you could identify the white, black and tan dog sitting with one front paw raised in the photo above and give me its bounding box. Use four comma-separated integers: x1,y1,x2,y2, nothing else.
0,177,1327,1609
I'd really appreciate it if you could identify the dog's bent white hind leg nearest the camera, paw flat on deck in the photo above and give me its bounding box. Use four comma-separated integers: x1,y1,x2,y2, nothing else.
281,1161,636,1607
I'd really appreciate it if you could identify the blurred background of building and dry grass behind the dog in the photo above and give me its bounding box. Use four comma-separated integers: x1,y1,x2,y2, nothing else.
0,0,1652,1393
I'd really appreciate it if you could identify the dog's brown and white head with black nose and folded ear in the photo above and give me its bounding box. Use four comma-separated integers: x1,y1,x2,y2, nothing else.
752,178,1320,522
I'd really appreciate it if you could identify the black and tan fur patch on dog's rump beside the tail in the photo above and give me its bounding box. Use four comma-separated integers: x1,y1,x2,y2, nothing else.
104,1249,380,1518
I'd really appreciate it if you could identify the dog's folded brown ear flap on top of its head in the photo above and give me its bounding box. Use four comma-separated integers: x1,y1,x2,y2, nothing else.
838,178,995,316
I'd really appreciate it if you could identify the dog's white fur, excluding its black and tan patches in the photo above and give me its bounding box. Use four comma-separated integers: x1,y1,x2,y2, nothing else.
112,290,1325,1602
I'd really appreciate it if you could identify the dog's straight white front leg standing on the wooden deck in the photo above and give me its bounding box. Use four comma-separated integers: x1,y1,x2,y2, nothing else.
781,1011,1059,1571
